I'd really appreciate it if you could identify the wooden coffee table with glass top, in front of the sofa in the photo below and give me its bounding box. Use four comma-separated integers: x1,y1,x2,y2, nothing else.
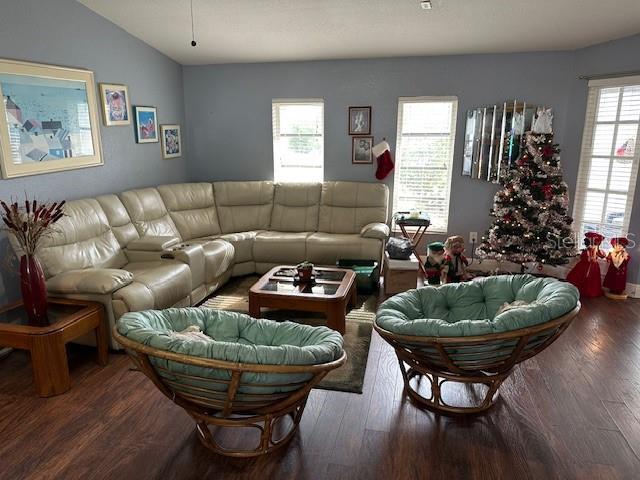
249,265,356,334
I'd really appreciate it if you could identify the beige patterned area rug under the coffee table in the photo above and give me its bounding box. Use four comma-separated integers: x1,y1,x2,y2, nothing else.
200,275,377,393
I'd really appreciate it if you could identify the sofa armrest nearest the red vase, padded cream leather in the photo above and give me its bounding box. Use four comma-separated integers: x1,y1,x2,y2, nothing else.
47,268,133,295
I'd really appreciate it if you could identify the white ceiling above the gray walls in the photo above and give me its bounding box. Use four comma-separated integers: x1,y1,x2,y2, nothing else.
78,0,640,65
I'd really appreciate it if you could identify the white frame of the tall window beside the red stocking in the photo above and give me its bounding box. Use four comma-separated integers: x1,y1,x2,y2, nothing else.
392,95,458,234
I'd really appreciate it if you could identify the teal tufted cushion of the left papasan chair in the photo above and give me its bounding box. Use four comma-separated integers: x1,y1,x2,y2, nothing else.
117,308,343,396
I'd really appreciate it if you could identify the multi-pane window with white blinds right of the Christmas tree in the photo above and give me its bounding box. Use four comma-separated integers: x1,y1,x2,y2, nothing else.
573,76,640,246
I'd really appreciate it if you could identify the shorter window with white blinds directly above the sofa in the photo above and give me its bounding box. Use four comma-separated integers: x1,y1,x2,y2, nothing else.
271,99,324,182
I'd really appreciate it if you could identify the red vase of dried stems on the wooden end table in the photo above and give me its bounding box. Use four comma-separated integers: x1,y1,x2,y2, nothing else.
0,200,65,325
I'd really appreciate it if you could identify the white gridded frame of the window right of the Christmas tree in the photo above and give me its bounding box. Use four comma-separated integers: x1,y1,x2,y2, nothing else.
573,75,640,241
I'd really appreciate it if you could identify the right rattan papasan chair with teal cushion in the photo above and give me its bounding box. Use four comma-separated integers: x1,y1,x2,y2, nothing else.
375,275,580,414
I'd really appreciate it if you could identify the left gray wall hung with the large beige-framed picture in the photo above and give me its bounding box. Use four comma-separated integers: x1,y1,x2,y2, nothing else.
0,0,187,304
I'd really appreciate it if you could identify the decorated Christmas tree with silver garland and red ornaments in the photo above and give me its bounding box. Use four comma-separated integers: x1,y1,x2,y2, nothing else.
477,132,576,271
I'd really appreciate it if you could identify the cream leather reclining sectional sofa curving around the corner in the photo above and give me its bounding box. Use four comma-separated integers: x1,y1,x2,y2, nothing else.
20,181,389,348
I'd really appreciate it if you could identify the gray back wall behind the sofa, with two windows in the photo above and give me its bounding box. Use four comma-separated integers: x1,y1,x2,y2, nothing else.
183,52,577,244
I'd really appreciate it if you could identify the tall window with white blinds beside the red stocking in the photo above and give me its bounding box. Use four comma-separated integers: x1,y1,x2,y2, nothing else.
393,97,458,233
